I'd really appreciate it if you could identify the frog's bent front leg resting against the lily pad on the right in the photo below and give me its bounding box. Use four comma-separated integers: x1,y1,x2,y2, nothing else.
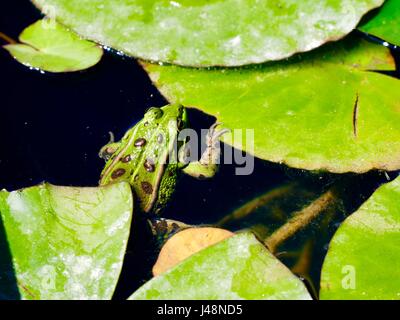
183,123,229,179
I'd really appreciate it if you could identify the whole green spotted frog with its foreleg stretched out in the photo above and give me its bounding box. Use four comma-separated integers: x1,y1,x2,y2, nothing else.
99,104,227,214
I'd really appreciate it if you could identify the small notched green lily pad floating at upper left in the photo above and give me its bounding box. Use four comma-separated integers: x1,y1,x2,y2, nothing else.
4,20,103,72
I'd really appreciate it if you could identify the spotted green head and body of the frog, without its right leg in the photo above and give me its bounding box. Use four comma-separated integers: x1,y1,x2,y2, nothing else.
100,105,186,212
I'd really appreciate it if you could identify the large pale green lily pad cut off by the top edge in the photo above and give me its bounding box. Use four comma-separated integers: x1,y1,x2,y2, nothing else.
33,0,383,66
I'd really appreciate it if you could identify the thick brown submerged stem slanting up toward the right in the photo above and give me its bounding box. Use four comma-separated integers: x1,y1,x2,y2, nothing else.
264,189,337,253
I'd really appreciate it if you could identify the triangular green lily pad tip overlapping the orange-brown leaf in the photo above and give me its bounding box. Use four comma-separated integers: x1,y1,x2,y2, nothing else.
130,233,311,300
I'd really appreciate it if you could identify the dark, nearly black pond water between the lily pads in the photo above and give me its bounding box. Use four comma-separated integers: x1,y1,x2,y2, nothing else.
0,0,400,298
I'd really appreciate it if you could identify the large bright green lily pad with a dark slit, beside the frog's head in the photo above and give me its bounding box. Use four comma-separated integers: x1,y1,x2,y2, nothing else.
144,37,400,173
